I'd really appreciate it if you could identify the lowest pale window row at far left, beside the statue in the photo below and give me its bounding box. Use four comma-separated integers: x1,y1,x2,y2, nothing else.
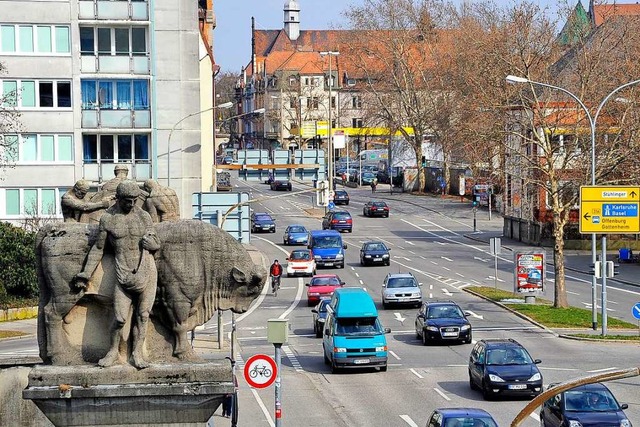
4,188,61,217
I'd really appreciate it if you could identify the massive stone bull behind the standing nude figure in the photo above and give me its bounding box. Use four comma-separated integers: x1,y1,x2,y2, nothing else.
36,220,267,365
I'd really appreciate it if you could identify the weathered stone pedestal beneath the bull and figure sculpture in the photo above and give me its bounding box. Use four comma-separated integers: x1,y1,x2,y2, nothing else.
22,360,234,427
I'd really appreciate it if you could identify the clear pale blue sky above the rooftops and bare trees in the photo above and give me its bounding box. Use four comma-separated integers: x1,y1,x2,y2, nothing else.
214,0,580,73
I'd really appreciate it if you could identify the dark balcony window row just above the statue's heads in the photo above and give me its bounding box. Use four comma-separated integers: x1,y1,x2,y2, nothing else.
82,134,150,163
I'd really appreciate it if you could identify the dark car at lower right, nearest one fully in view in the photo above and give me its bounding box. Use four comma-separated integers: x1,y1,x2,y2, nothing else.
469,339,542,400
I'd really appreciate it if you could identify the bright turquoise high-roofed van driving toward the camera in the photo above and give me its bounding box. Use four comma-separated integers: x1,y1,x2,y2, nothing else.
322,288,391,373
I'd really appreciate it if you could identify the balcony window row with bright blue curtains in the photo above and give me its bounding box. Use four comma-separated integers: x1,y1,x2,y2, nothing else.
81,80,149,110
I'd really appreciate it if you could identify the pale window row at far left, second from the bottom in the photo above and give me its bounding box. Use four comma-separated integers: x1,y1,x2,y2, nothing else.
4,134,73,164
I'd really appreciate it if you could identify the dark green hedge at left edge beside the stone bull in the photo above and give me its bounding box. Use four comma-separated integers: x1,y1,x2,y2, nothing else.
0,222,38,302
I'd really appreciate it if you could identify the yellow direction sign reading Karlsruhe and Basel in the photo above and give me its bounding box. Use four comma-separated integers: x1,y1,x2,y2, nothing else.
580,186,640,234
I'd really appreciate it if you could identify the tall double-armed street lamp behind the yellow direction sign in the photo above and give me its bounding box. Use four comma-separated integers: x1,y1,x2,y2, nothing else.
506,75,640,335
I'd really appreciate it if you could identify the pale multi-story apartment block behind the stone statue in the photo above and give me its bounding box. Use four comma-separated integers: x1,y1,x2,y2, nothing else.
0,0,213,223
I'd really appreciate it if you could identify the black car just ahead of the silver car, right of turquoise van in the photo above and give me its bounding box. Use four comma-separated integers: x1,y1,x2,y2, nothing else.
415,301,472,345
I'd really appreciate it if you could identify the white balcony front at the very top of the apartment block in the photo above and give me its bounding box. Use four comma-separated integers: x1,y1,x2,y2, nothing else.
78,0,149,21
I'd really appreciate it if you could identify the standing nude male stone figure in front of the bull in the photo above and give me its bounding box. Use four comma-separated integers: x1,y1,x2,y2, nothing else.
76,180,160,369
